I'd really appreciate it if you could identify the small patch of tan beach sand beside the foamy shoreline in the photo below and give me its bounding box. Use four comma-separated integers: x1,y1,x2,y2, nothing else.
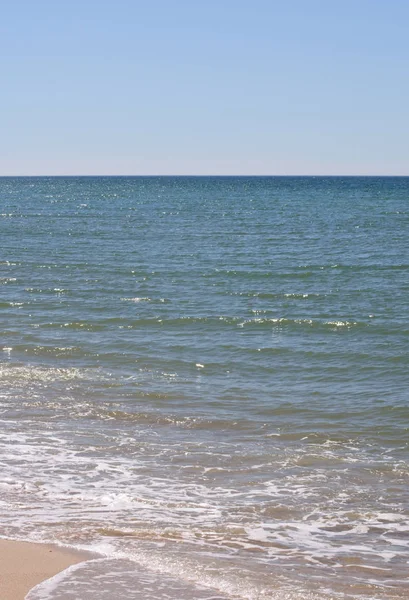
0,540,87,600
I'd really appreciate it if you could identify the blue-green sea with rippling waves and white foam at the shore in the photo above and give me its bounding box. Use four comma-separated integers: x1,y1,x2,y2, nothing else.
0,177,409,600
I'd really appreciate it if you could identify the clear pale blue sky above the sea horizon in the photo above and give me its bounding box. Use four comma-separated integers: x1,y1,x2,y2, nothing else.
0,0,409,175
